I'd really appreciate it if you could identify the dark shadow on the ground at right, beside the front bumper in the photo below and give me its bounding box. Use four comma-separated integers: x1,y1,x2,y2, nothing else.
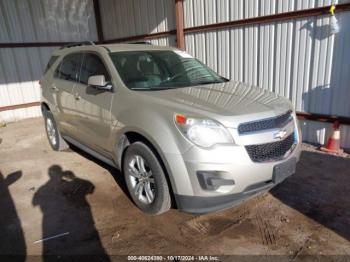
271,151,350,241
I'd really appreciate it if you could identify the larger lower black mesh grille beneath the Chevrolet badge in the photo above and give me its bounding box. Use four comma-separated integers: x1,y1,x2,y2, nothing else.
245,132,295,162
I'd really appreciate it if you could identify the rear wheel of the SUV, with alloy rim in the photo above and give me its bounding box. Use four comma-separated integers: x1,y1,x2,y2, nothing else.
43,110,69,151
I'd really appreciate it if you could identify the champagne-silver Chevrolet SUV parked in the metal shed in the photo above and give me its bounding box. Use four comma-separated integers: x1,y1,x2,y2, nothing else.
41,43,301,214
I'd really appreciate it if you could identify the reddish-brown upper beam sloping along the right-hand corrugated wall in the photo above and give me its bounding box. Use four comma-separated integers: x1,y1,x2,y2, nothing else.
184,3,350,34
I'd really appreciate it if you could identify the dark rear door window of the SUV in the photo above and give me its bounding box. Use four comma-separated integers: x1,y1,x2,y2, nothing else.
55,53,83,81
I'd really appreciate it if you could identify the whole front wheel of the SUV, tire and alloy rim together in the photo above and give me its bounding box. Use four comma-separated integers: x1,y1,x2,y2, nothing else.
123,142,171,215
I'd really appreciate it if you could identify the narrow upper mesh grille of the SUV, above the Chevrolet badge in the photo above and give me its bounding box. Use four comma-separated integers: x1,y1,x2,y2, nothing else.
238,110,293,135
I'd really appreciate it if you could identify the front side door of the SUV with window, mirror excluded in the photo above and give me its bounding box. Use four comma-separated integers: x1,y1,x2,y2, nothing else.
74,52,114,156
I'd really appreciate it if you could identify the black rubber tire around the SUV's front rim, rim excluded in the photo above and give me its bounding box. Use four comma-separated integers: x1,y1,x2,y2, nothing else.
123,142,170,215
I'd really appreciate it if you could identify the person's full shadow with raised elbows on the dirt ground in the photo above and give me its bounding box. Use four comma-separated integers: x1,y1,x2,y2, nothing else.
32,165,109,261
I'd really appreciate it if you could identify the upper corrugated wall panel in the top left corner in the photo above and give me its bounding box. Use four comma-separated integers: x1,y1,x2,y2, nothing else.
0,0,97,43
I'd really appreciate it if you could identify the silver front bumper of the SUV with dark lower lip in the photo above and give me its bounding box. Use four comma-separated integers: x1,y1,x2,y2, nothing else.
167,131,301,213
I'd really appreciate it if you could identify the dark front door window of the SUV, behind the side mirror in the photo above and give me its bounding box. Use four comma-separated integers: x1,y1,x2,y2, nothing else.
79,53,111,85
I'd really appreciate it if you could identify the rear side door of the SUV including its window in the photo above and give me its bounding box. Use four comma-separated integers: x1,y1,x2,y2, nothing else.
51,53,83,137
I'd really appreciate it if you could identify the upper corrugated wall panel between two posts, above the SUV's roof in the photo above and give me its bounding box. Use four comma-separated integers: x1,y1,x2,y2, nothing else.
100,0,175,40
